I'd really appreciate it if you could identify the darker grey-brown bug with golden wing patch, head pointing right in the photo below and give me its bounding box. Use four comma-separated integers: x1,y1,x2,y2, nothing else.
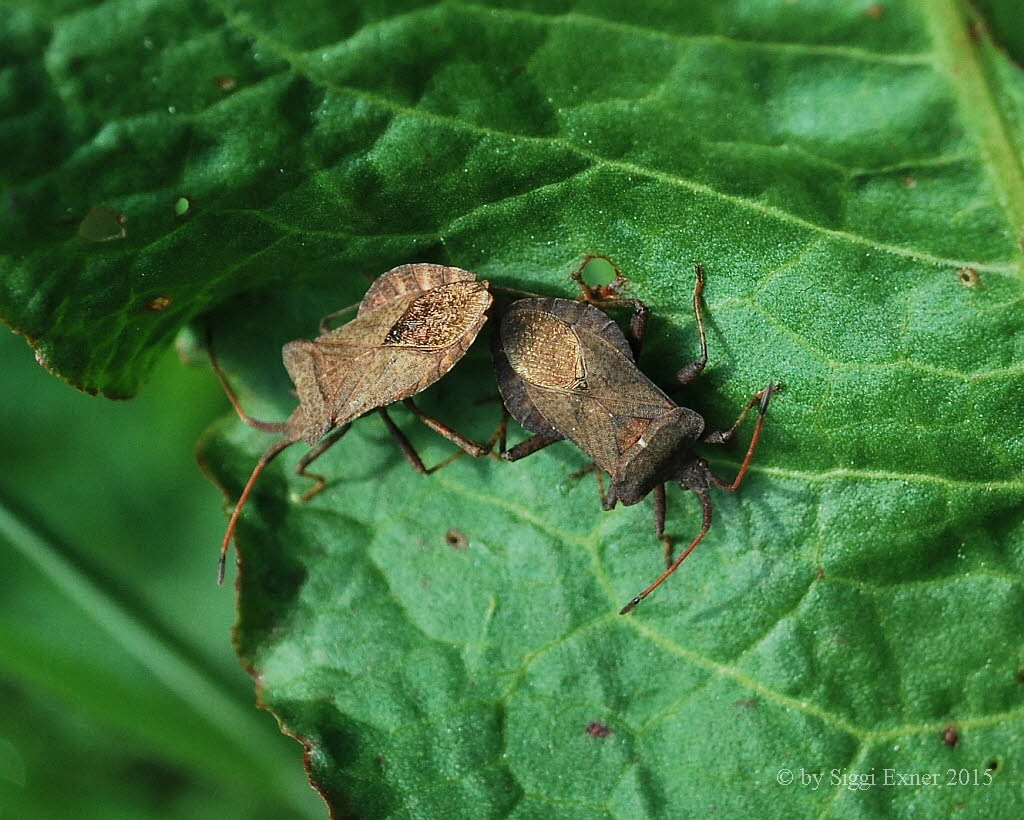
494,265,781,614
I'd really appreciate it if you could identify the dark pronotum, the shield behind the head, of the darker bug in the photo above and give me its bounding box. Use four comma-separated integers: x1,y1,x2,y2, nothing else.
612,407,703,506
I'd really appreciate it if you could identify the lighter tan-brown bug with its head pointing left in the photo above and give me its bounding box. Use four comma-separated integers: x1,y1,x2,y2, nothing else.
209,263,492,582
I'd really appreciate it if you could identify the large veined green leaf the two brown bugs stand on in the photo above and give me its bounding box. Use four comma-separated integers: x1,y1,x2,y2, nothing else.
0,0,1024,817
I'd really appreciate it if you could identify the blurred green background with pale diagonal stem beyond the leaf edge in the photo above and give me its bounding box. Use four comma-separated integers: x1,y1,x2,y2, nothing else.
0,331,324,820
